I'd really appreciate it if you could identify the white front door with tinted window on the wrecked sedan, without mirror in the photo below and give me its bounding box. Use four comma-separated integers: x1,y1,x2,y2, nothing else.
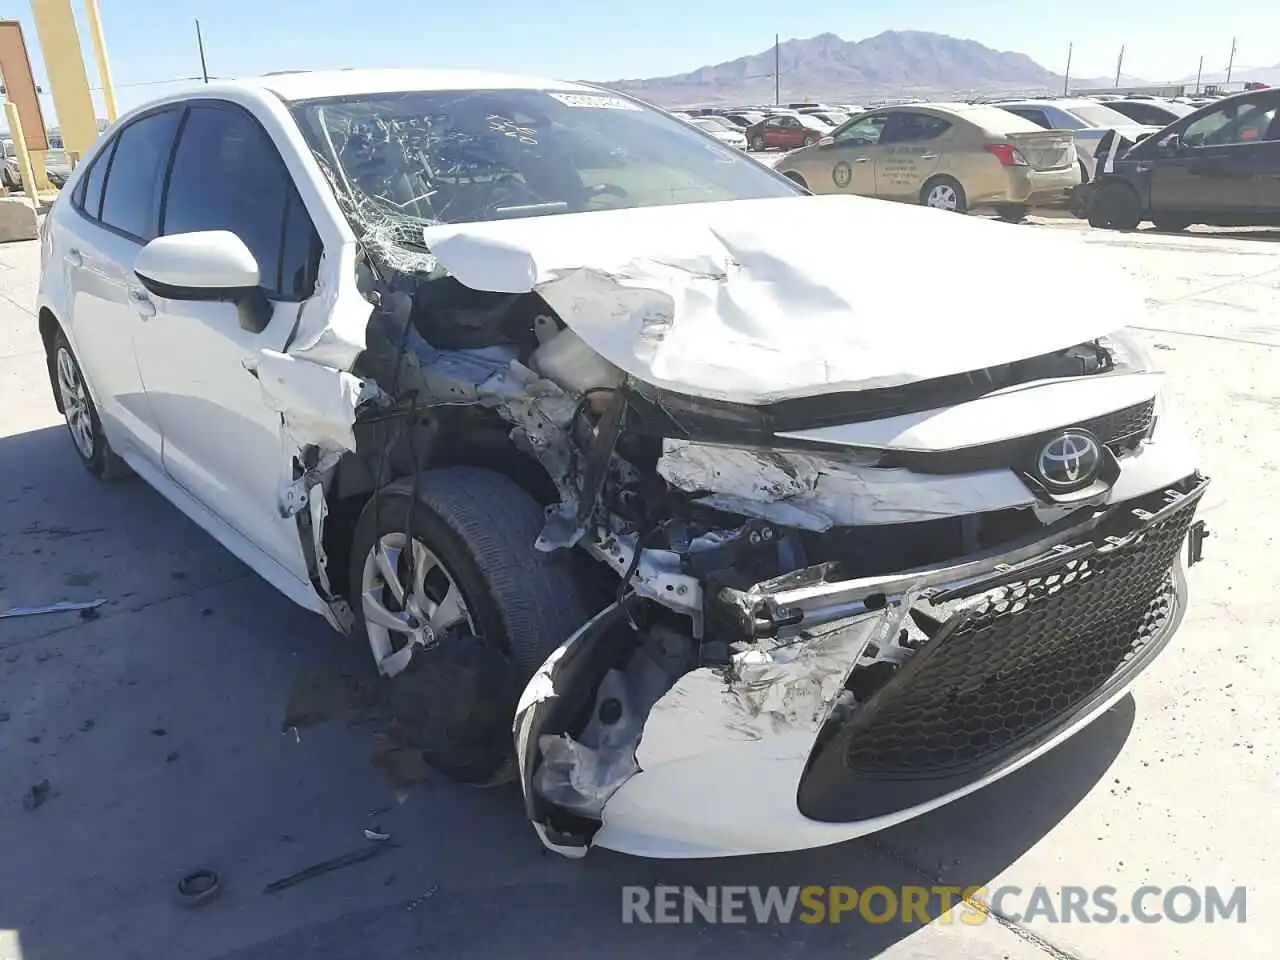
134,100,320,582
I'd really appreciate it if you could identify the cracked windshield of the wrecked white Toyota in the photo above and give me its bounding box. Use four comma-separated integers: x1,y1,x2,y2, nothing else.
293,90,796,236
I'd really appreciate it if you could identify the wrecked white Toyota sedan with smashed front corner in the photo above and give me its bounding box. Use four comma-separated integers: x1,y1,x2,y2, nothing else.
38,70,1207,856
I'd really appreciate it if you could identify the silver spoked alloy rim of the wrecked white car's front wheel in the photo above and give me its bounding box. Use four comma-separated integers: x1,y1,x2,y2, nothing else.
360,532,475,677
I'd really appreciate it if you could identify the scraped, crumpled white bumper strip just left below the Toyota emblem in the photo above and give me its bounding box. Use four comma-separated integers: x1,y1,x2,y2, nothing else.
658,439,1036,532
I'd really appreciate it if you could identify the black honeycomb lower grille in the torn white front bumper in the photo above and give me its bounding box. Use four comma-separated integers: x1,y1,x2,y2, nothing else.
799,486,1203,820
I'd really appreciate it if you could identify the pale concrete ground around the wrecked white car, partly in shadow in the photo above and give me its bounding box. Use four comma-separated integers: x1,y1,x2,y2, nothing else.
0,220,1280,960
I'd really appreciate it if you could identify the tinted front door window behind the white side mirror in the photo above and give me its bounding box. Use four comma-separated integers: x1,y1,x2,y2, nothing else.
163,104,319,301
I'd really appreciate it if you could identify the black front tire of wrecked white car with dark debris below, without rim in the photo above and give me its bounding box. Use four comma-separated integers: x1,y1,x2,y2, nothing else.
348,466,591,783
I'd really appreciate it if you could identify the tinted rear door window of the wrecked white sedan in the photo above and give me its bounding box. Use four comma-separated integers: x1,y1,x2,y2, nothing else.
101,110,182,243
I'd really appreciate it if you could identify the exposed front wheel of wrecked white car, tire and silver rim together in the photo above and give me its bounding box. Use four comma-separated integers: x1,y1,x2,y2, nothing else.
348,467,590,783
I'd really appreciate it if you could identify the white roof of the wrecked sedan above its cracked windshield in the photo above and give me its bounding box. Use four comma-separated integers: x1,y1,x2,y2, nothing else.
232,69,602,100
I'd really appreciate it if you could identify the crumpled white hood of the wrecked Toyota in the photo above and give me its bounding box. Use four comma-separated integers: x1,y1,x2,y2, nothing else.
424,196,1143,403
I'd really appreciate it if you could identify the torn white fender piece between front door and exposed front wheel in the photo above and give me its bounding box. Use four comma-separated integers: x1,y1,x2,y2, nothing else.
252,349,380,451
